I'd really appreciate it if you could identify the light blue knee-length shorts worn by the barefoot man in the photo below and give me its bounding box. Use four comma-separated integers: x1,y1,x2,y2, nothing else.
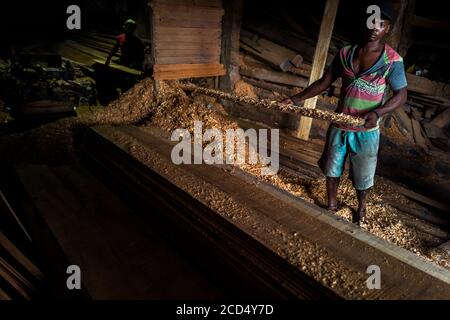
319,127,380,190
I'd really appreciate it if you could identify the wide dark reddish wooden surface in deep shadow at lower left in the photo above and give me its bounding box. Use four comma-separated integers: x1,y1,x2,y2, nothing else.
17,165,223,299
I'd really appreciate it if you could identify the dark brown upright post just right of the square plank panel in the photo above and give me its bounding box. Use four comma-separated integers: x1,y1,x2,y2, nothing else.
219,0,243,92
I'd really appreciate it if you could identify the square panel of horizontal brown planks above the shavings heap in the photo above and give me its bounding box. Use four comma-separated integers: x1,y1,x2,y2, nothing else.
151,0,225,80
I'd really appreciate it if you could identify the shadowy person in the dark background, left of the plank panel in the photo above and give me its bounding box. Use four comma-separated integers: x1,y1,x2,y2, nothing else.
105,19,144,70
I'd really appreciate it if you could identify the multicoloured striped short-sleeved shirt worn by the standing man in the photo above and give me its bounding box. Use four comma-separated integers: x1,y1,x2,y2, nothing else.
330,44,407,131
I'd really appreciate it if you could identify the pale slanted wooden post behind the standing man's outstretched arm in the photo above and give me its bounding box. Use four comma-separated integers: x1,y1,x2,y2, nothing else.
297,0,339,140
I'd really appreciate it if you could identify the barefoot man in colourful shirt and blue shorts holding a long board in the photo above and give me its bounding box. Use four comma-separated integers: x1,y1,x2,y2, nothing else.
284,2,407,224
